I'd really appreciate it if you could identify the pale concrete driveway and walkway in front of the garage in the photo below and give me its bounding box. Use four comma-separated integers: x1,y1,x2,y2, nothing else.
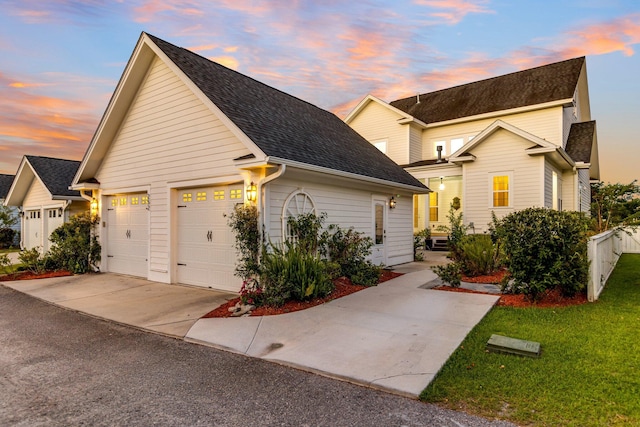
4,263,498,398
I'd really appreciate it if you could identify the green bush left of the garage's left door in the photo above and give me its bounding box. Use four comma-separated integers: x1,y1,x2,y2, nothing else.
45,212,100,274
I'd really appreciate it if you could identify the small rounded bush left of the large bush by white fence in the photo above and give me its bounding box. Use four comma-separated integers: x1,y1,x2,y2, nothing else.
459,234,501,276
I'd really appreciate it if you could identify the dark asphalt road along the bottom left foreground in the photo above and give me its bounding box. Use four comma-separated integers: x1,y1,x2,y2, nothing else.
0,286,509,427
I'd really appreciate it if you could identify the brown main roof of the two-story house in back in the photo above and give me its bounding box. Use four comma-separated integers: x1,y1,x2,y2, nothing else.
390,56,585,124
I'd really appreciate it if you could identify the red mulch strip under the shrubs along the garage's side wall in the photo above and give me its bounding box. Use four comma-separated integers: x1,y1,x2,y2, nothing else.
202,270,402,319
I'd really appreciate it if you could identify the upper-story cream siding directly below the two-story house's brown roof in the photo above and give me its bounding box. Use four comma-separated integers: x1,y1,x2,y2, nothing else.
422,107,563,160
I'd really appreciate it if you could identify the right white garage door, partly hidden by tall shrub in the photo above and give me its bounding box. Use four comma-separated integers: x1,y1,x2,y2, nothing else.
176,185,244,292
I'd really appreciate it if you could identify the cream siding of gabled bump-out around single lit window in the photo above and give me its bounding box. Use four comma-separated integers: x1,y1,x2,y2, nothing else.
462,129,544,232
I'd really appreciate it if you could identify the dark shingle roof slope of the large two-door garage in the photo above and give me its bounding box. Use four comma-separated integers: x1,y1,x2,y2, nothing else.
147,34,426,189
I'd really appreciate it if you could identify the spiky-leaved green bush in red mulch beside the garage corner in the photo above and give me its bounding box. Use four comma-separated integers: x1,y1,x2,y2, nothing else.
261,242,334,306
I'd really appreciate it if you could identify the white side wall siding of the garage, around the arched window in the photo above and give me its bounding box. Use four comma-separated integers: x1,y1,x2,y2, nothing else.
267,177,413,265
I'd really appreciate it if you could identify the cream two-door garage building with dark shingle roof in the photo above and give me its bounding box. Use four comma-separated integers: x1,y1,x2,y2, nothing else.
72,33,428,291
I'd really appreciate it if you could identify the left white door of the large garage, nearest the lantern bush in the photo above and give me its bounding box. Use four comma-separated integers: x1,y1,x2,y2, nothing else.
106,193,149,278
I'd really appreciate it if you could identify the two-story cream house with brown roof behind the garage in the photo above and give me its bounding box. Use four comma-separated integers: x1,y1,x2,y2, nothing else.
345,57,599,234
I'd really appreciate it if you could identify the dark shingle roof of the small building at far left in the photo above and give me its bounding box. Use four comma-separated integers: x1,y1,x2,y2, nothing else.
25,156,80,197
